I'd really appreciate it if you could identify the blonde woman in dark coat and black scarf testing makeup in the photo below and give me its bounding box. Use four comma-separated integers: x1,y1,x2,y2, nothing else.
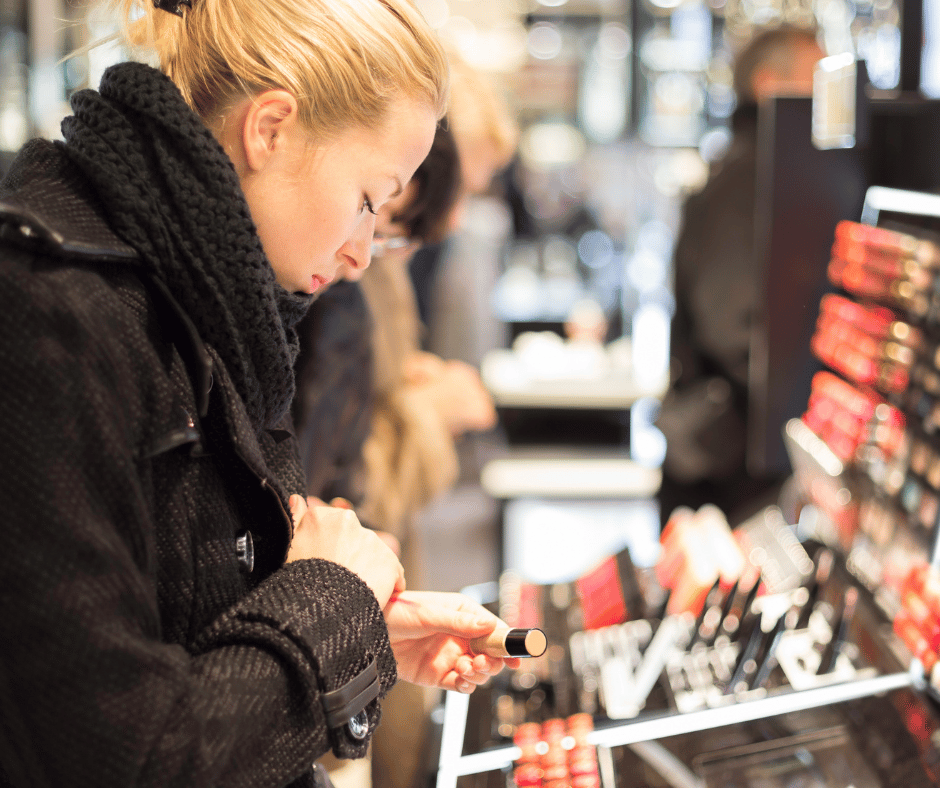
0,0,505,788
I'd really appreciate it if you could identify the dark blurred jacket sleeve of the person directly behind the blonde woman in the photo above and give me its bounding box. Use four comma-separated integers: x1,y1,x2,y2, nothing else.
292,281,374,505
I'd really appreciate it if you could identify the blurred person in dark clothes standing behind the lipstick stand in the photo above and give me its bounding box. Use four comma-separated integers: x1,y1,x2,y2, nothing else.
657,26,823,525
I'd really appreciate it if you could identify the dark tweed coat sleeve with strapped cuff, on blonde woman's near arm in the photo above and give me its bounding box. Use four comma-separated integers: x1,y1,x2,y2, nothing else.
0,259,395,788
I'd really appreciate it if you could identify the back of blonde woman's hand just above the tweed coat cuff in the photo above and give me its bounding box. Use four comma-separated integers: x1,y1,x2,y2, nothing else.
287,495,405,609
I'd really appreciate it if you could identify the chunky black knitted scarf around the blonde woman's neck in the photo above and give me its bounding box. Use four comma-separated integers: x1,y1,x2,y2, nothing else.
62,63,312,429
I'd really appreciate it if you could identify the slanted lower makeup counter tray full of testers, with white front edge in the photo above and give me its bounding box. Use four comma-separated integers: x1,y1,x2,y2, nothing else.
442,540,940,788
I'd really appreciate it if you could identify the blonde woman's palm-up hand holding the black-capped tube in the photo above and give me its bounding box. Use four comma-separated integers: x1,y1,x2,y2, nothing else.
385,591,519,694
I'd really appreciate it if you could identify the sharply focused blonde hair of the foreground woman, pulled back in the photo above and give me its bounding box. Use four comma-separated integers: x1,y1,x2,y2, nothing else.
110,0,448,138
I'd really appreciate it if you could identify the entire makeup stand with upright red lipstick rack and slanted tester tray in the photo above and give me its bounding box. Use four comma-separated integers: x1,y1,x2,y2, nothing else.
436,35,940,788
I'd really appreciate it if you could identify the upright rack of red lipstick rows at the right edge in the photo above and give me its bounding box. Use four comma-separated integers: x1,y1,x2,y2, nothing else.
788,219,940,604
